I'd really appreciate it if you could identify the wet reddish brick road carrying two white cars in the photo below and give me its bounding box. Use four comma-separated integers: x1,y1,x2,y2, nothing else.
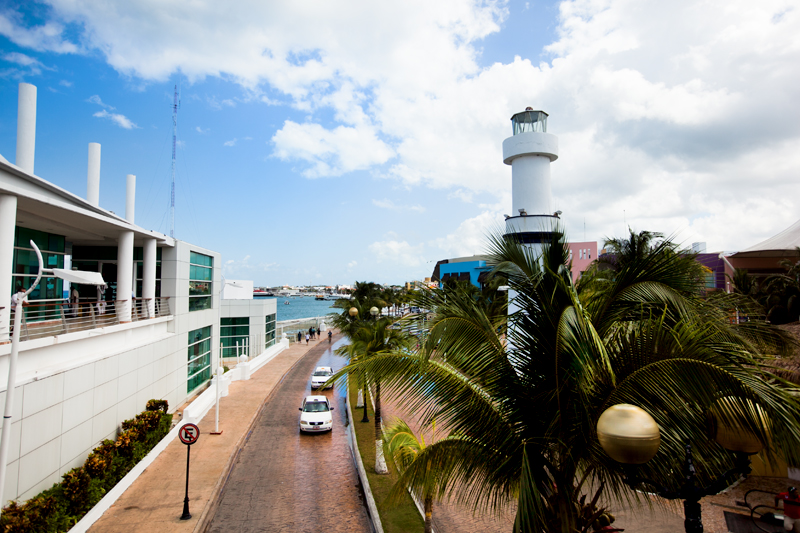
209,336,371,533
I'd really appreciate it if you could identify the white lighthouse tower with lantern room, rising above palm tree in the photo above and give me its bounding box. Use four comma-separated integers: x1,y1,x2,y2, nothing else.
503,107,561,252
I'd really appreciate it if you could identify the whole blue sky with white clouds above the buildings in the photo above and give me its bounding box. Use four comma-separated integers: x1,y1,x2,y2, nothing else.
0,0,800,285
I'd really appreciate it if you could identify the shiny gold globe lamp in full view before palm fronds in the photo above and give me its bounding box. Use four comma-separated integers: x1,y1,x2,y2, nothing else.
597,404,661,465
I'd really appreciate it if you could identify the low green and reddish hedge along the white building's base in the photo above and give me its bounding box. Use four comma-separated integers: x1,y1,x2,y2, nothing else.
0,400,172,533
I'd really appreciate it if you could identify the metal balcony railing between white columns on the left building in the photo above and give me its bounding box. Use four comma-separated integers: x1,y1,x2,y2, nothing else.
10,298,170,341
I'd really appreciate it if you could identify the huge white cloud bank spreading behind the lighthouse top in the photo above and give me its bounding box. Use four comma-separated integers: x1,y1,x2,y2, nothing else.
9,0,800,249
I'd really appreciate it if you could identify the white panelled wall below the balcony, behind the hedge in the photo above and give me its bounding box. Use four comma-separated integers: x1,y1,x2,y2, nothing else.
0,241,225,502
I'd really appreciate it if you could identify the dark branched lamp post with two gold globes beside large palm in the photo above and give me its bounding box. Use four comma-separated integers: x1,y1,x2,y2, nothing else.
597,404,766,533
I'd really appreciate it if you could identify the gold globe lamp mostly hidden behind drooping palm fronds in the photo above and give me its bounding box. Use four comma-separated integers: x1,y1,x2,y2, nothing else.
710,396,772,455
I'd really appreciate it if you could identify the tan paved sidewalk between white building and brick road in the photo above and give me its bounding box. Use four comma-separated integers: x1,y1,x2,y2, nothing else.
89,335,338,533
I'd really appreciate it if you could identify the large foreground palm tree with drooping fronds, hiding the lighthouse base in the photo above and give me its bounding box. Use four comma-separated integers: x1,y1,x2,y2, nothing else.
336,228,800,533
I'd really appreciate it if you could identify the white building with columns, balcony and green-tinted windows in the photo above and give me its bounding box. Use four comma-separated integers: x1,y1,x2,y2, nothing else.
0,84,275,502
